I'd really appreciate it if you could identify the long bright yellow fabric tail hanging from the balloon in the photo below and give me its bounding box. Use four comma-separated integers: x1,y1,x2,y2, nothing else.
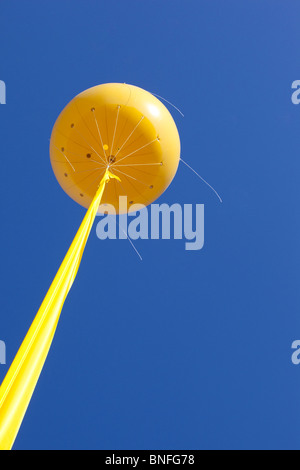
0,170,119,450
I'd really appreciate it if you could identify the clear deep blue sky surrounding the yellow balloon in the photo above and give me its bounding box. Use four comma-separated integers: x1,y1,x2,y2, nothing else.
0,0,300,450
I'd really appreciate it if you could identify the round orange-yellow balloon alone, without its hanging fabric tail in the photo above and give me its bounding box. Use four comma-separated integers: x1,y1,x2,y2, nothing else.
50,83,180,213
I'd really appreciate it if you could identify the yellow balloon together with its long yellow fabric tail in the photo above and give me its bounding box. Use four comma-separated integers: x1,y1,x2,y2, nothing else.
0,84,180,450
